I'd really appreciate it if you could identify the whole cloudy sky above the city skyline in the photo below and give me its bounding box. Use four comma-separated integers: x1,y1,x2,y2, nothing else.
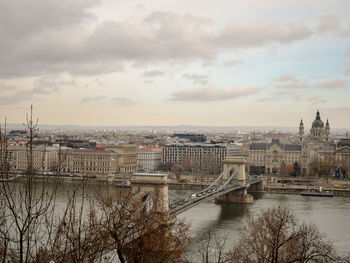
0,0,350,128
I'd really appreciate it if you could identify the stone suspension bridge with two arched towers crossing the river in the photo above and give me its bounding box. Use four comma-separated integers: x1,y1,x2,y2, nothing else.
131,157,262,216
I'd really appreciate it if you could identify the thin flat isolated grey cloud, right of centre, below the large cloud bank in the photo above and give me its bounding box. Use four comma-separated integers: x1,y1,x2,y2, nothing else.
172,86,259,102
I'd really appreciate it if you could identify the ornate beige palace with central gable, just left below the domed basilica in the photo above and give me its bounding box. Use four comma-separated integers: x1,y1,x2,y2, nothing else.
243,139,309,175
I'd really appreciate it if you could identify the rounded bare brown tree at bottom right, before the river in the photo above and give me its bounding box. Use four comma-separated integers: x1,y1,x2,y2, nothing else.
230,206,340,263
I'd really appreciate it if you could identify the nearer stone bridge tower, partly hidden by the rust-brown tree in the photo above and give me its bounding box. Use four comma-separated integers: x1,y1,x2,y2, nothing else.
131,173,169,213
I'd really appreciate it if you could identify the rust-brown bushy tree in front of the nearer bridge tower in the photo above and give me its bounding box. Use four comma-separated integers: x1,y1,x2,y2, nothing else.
93,190,190,263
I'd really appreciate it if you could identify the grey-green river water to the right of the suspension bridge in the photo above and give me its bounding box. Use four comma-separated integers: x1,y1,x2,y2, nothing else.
173,190,350,255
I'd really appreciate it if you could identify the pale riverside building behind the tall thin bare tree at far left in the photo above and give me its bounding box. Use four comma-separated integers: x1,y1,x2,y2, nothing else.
8,145,58,173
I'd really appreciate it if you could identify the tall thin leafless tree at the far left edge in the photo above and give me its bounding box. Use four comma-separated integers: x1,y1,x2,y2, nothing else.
0,107,57,263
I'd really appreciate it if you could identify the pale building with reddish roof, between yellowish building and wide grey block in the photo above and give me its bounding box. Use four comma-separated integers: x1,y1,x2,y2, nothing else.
136,148,162,172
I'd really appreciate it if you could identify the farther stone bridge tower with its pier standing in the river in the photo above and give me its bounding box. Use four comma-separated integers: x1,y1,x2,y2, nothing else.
216,157,254,204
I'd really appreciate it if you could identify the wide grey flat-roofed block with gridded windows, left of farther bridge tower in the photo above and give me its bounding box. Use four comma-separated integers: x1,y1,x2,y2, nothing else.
162,143,227,173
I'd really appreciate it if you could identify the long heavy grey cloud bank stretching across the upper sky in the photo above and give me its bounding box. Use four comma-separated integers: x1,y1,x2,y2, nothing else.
0,0,348,78
